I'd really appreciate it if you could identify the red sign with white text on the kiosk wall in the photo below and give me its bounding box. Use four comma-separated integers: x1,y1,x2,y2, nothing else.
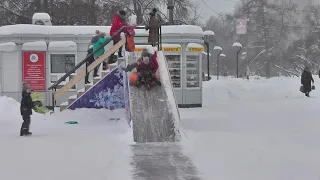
22,51,46,91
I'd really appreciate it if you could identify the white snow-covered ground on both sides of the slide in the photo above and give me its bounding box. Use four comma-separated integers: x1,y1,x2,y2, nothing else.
0,77,320,180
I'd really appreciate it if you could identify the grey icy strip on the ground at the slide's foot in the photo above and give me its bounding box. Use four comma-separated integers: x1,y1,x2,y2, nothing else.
131,143,200,180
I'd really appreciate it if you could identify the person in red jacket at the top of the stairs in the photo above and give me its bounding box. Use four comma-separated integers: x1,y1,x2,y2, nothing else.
110,10,127,60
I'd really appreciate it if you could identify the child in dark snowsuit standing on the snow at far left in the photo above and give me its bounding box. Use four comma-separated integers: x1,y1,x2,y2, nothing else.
20,83,35,136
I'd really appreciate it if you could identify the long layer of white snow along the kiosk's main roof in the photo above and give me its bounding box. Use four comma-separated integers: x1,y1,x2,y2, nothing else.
0,24,203,36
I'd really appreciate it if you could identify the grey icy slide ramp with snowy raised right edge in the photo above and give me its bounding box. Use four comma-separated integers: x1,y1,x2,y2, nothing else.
126,51,180,143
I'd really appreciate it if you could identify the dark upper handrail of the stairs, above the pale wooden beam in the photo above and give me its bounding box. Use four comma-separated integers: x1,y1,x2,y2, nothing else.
48,26,127,90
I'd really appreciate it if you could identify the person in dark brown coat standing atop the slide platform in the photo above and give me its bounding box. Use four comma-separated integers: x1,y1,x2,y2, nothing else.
146,8,162,46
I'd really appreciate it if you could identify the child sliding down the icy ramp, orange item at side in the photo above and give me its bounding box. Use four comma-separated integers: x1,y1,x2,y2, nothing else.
125,48,161,89
